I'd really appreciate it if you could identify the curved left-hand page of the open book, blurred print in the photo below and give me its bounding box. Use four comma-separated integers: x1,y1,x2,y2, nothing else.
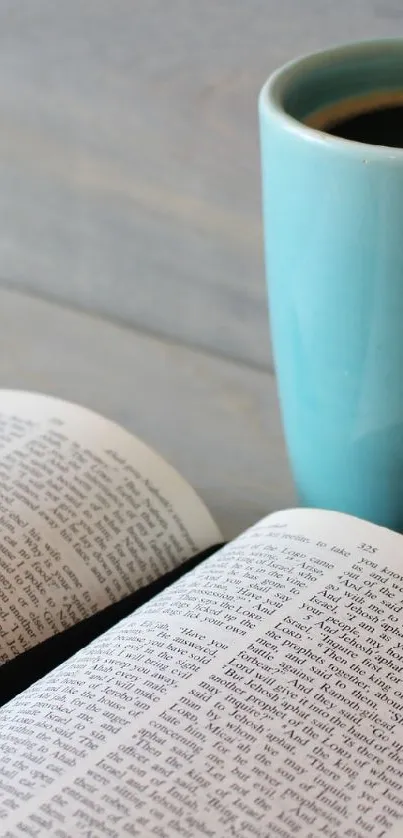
0,391,221,663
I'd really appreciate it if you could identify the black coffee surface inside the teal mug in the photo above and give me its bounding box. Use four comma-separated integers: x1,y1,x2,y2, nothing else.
322,104,403,148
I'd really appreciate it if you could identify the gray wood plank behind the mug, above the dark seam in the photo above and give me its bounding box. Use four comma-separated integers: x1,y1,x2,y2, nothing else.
0,0,403,366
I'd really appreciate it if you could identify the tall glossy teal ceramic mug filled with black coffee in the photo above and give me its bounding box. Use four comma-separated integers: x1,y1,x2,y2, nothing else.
259,40,403,530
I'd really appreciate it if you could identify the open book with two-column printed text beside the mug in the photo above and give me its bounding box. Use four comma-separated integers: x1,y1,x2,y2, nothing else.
0,392,403,838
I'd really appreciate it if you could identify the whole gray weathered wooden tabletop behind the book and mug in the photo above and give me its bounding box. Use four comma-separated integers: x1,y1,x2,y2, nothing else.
0,0,403,537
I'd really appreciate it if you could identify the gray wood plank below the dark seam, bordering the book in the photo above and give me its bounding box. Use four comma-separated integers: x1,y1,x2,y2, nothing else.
0,289,293,538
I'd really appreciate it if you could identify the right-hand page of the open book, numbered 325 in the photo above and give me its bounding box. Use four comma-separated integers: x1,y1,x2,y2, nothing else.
0,510,403,838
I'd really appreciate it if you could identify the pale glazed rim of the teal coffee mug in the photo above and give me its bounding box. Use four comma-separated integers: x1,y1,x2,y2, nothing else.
258,38,403,162
